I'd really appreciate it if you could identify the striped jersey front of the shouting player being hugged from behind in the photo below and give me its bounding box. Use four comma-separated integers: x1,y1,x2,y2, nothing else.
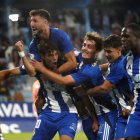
37,74,77,113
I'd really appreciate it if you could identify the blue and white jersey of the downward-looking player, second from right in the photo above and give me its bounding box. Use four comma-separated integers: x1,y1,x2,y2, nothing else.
106,56,132,114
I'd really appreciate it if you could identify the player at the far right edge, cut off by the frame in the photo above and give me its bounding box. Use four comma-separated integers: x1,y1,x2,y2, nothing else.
121,23,140,140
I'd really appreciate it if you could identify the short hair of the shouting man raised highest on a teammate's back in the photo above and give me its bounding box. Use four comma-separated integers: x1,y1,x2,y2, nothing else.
29,9,51,22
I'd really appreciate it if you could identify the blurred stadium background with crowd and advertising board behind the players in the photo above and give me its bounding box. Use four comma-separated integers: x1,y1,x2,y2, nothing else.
0,0,140,140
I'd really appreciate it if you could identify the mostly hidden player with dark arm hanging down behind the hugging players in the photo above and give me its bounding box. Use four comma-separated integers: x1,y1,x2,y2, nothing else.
69,49,99,140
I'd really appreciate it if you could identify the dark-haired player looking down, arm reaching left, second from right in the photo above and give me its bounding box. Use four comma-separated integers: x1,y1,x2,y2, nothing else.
83,35,132,140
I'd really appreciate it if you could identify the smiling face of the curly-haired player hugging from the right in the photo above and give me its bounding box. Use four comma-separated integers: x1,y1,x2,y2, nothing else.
82,40,96,59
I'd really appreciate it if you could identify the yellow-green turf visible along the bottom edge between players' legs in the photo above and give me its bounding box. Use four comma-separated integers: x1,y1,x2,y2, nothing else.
4,132,87,140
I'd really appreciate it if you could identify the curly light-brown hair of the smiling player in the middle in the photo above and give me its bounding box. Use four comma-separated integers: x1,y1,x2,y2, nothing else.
84,31,103,51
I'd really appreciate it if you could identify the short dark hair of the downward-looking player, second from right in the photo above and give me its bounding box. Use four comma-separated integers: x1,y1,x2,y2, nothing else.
103,34,121,48
